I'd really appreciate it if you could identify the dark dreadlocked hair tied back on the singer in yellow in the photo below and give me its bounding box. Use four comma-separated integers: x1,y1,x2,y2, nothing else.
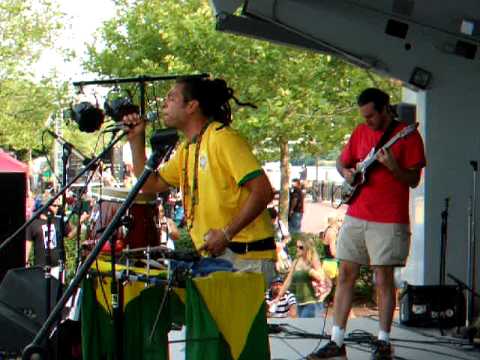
177,77,257,126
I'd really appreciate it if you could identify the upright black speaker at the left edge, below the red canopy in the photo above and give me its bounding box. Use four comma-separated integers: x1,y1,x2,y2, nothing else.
0,173,27,281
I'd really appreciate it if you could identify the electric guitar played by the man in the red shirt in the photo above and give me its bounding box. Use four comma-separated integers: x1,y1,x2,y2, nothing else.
335,123,418,207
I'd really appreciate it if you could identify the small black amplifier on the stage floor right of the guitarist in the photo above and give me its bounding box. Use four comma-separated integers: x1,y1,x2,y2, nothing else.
400,285,465,328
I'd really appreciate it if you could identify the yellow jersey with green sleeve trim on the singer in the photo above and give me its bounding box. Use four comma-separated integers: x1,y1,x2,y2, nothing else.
160,122,275,259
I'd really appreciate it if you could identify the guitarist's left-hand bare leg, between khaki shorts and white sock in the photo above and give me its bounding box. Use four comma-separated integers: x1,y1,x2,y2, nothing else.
333,261,360,329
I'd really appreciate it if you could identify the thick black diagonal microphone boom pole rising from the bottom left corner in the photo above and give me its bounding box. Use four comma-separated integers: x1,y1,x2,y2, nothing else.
22,147,169,360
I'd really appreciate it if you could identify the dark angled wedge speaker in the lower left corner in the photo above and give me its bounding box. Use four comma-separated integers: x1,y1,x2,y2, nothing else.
0,267,60,353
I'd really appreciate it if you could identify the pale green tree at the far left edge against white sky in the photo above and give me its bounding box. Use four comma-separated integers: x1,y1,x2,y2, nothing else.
0,0,66,158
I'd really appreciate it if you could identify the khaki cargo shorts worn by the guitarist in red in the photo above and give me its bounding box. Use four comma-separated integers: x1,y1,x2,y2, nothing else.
337,216,410,266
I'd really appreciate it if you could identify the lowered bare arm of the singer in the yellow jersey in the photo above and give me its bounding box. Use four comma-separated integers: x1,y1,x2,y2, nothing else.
203,172,273,255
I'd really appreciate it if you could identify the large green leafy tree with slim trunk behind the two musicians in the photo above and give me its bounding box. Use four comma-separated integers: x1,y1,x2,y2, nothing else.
87,0,402,218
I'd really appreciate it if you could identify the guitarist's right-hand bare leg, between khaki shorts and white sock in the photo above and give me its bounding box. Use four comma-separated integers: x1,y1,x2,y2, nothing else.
375,266,395,333
